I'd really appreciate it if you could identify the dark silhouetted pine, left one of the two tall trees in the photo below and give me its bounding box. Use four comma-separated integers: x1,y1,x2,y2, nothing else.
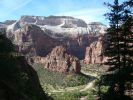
105,0,123,96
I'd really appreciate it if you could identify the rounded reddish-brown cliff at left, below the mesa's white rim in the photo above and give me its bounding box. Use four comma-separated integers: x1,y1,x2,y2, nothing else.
7,25,59,56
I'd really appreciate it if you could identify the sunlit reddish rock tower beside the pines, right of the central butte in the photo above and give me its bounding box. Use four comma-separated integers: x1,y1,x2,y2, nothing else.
84,36,107,64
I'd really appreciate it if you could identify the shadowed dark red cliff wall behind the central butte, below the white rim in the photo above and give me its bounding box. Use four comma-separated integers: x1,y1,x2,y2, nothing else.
7,23,97,59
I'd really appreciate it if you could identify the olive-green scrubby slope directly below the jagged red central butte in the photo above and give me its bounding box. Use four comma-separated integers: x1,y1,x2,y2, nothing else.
33,64,92,88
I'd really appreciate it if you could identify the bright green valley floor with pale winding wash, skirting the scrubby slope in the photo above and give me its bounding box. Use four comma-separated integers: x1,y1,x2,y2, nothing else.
32,65,103,100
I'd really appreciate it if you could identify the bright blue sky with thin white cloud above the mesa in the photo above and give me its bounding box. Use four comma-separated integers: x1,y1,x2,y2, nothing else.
0,0,123,24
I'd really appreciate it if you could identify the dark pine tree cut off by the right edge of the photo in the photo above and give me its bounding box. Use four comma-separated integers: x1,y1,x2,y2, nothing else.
119,0,133,95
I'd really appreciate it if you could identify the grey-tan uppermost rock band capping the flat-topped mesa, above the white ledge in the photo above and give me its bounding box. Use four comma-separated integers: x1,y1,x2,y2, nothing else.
20,16,87,27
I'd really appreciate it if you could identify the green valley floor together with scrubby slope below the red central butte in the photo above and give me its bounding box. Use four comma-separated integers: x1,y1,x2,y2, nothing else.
33,64,103,100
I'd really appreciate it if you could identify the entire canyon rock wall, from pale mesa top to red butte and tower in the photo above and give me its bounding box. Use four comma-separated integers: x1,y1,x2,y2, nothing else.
0,16,107,73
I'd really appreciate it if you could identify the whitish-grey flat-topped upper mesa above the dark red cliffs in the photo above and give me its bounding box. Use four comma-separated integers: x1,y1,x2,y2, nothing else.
7,16,107,38
